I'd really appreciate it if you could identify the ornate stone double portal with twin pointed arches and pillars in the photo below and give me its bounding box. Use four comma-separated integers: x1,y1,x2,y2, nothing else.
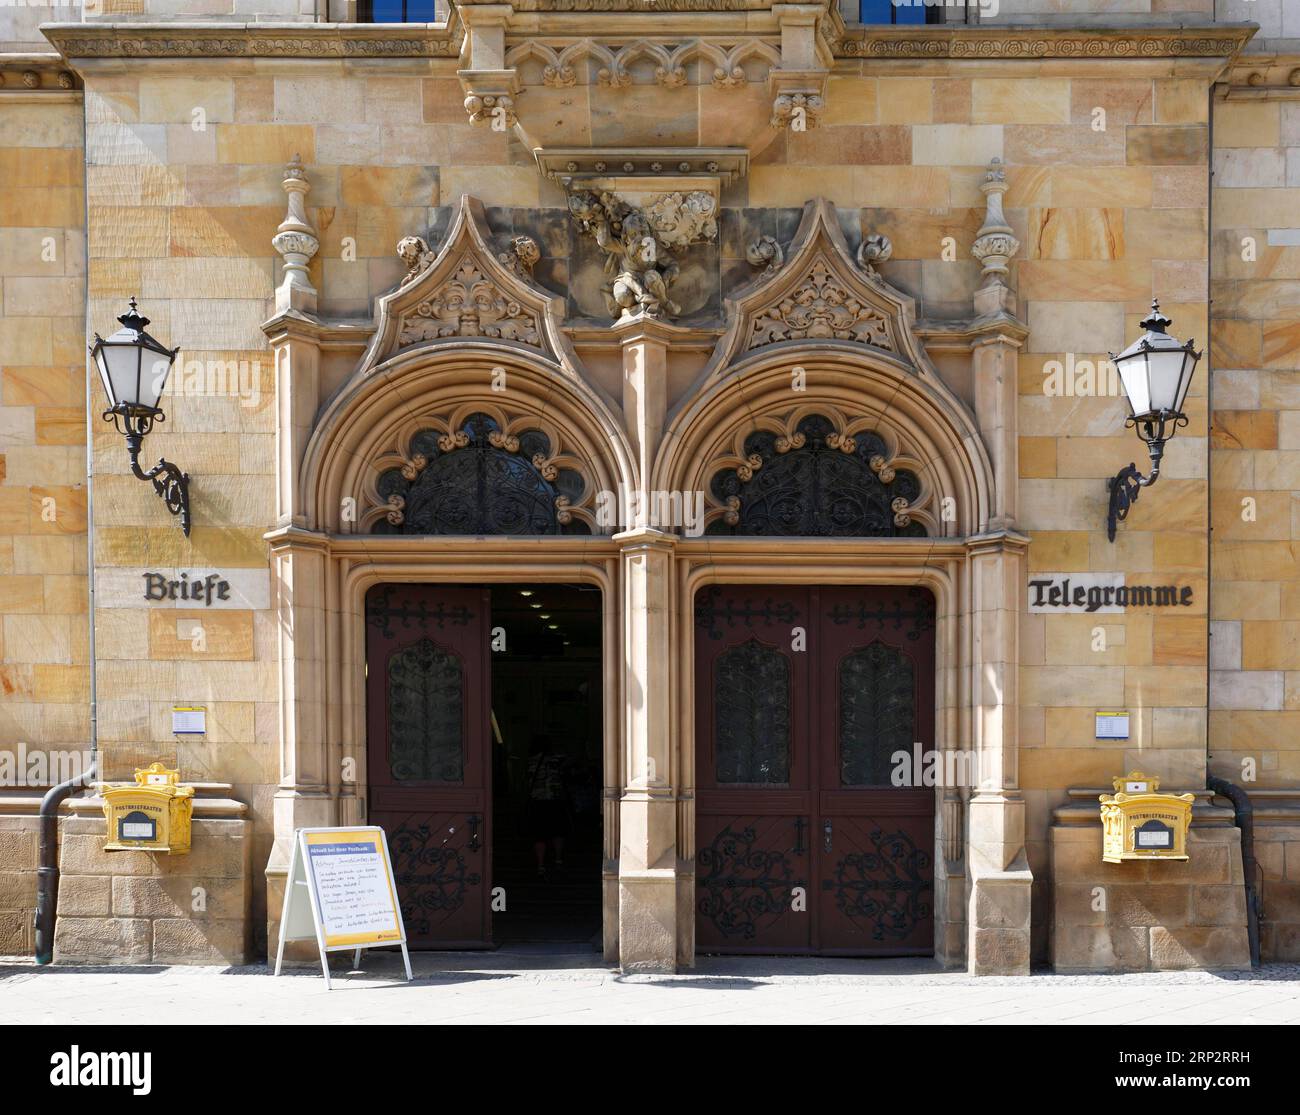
267,156,1031,972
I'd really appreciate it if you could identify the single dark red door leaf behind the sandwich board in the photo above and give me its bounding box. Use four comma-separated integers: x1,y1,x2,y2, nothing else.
365,585,491,949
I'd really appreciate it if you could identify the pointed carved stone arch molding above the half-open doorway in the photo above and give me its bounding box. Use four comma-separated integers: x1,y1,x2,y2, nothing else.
300,196,638,534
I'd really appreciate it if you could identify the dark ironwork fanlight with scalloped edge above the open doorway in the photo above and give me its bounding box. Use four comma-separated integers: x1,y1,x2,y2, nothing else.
372,412,590,534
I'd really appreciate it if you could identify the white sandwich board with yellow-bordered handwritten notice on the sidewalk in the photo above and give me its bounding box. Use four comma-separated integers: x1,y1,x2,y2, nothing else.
276,825,412,988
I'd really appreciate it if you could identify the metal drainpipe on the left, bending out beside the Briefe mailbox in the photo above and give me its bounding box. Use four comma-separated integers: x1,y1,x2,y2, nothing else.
35,92,99,964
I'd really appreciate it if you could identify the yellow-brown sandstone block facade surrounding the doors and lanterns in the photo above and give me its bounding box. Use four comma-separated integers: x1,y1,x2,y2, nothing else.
0,0,1300,972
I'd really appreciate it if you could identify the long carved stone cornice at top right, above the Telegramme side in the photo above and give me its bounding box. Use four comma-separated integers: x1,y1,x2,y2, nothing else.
835,23,1256,60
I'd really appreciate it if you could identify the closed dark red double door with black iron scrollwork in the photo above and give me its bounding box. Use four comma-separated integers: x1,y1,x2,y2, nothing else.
696,585,935,955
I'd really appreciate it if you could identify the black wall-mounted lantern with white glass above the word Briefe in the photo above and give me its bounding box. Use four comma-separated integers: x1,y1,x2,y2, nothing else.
90,298,190,535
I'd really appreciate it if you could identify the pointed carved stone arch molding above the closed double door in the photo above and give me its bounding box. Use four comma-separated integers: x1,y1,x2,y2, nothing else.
651,199,993,537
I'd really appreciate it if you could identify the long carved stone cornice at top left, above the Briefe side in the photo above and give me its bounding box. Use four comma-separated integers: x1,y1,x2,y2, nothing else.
40,19,463,60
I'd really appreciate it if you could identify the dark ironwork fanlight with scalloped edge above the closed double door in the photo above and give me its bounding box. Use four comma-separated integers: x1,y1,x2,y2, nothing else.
709,415,926,538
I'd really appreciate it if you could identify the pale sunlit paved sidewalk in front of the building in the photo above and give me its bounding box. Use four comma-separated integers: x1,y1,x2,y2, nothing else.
0,950,1300,1025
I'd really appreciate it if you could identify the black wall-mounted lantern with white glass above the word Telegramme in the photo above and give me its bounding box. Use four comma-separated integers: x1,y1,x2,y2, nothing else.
1106,300,1201,542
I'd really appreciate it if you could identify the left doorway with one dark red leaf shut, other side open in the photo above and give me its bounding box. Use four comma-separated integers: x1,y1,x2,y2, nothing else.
365,583,603,950
